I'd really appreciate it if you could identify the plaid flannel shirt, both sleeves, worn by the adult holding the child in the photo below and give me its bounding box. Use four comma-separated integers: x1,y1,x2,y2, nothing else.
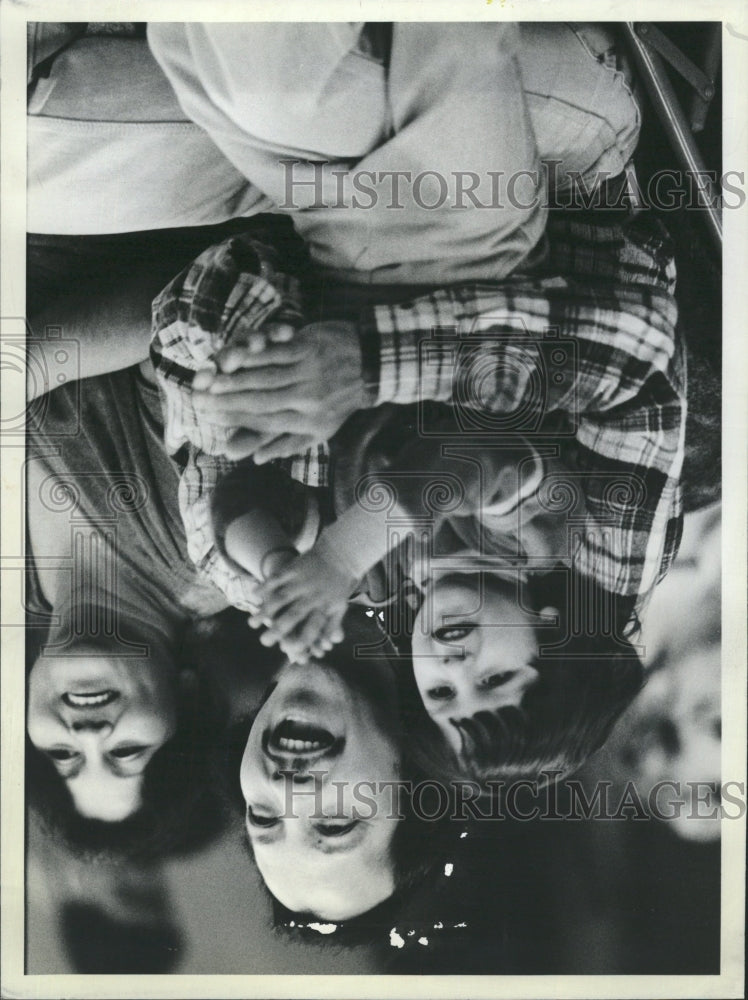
151,211,685,609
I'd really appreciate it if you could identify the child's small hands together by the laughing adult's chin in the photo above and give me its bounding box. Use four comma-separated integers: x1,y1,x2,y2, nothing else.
249,549,357,662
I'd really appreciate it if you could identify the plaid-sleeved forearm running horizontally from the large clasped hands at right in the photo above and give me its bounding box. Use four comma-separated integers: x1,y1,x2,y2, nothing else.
361,281,675,413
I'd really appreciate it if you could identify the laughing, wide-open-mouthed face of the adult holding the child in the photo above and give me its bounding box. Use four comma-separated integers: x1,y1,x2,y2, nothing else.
240,662,400,921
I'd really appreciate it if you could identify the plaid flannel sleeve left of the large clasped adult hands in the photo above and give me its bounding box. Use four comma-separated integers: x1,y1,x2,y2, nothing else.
150,235,327,611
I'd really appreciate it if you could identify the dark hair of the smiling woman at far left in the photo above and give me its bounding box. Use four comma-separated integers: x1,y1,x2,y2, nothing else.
25,624,230,861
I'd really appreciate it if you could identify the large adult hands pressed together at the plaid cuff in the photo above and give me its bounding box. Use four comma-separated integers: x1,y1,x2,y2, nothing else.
193,321,368,462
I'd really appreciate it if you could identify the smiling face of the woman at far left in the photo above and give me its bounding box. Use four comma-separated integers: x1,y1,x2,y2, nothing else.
27,649,176,822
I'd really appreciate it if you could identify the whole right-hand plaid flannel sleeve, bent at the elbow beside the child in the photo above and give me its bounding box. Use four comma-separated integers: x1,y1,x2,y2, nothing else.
361,213,686,608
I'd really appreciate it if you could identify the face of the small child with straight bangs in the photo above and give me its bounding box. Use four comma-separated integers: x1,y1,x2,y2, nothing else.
412,574,554,752
